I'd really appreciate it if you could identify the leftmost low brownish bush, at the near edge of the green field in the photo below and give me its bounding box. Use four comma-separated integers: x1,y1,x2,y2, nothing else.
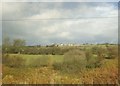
2,54,25,67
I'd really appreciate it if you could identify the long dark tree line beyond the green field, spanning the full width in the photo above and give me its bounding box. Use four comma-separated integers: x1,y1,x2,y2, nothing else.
2,38,118,55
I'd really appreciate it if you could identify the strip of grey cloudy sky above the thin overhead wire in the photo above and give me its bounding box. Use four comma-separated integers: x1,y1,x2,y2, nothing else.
3,2,117,20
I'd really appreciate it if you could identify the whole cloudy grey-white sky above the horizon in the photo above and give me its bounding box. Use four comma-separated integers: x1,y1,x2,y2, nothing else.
0,2,118,45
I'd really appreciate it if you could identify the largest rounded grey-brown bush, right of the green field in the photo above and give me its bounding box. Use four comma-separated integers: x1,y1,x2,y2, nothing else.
53,49,86,73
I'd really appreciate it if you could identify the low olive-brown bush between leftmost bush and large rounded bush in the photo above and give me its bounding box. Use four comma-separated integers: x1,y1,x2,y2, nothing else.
29,56,50,67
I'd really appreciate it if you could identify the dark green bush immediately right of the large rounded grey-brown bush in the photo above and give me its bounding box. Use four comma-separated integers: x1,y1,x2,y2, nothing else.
85,47,104,68
